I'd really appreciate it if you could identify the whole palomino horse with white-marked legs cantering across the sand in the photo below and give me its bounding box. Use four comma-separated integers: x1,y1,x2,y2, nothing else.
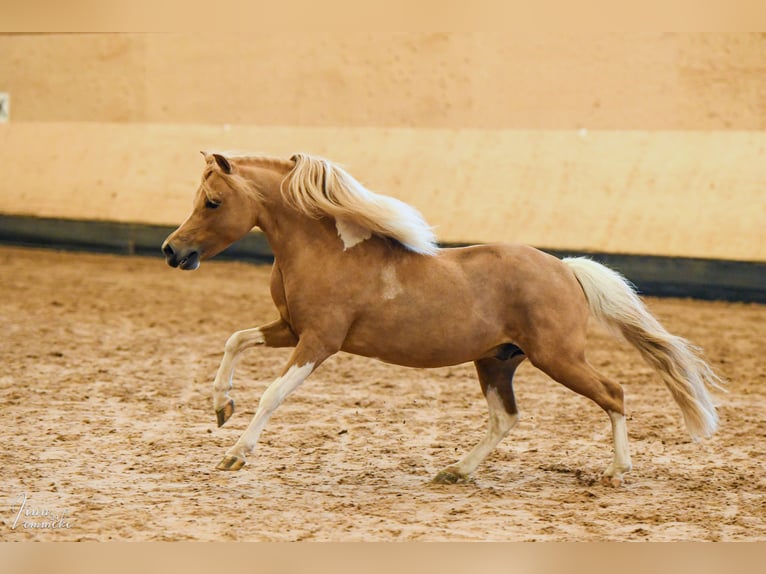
162,152,719,486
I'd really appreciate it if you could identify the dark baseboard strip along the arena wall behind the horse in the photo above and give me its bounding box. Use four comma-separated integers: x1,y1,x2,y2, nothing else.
0,214,766,303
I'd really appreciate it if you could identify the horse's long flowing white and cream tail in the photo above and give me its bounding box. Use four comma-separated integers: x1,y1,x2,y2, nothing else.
564,258,722,440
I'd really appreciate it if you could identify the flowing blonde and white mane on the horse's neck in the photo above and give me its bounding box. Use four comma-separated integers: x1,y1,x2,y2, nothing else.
282,153,438,255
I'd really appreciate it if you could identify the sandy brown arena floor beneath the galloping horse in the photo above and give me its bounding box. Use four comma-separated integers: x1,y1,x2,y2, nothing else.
0,248,766,541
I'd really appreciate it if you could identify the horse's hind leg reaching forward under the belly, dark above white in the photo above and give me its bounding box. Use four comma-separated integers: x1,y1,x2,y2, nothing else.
434,355,524,484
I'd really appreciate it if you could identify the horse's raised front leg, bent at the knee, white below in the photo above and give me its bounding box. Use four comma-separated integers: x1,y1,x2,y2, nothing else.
213,319,298,427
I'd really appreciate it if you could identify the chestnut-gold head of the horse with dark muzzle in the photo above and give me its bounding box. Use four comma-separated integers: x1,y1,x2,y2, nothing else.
162,152,256,270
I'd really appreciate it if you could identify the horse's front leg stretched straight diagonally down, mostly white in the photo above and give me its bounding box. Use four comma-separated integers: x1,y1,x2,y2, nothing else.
216,336,337,470
